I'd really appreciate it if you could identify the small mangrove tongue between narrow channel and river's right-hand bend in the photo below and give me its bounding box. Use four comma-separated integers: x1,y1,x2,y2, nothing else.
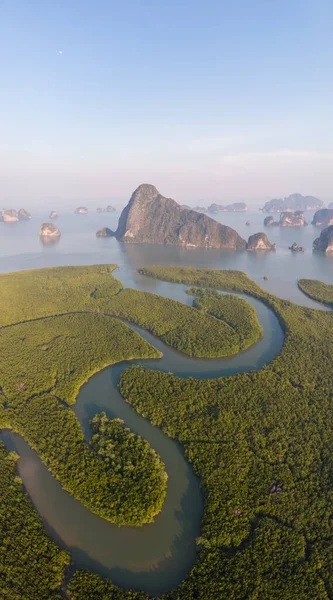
188,288,262,350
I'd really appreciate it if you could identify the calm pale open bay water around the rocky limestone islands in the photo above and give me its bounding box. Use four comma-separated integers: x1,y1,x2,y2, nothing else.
0,211,333,305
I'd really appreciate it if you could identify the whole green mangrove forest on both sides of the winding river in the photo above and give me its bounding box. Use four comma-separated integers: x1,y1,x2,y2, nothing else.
0,266,333,600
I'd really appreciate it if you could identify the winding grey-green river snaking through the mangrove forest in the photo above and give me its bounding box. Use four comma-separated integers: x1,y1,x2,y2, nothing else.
1,283,283,595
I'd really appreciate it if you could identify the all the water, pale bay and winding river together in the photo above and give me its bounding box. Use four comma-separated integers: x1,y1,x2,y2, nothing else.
0,213,333,594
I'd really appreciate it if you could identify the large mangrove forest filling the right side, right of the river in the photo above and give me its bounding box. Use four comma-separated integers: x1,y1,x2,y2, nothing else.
76,268,333,600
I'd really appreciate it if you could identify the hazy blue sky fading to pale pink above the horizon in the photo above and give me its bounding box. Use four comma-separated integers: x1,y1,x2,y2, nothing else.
0,0,333,207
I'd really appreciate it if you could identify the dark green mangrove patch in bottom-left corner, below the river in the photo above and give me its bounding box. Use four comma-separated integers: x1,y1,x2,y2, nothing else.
0,442,70,600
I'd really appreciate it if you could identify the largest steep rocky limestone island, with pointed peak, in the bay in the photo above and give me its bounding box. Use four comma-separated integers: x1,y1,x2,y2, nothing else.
113,184,246,249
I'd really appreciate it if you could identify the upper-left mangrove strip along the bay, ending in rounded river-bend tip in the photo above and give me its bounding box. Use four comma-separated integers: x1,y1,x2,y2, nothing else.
0,265,256,358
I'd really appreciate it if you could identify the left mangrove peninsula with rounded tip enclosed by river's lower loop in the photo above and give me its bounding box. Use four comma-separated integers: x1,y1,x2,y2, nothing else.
0,314,166,525
